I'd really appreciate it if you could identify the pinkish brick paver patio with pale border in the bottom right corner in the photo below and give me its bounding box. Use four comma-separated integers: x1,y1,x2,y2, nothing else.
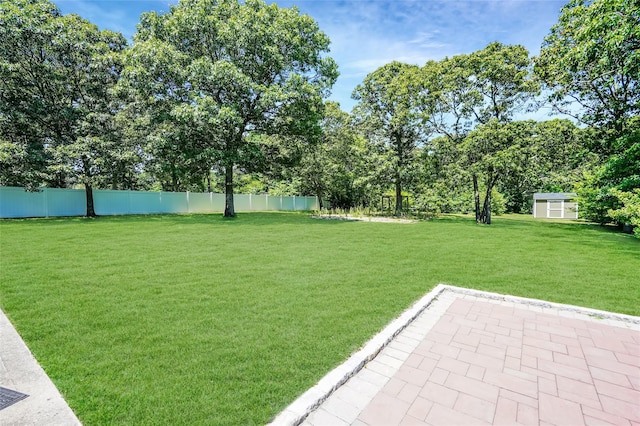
288,291,640,426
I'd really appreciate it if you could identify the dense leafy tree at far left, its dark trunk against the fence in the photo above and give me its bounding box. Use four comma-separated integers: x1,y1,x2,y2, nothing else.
0,0,126,216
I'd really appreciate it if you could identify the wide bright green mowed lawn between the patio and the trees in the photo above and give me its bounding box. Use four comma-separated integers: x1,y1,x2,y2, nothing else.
0,213,640,425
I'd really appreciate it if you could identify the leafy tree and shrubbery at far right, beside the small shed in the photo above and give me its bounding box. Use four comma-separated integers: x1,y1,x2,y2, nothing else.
535,0,640,230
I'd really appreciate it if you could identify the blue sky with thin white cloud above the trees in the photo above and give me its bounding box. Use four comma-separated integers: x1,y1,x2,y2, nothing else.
54,0,566,111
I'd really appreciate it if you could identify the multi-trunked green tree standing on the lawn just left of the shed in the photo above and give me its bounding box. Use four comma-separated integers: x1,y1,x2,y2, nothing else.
416,42,538,223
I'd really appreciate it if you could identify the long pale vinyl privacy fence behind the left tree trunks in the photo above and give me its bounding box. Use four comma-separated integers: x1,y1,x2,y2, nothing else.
0,186,318,218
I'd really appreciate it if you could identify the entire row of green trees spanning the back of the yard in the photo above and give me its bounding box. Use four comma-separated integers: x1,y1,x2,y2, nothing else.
0,0,640,236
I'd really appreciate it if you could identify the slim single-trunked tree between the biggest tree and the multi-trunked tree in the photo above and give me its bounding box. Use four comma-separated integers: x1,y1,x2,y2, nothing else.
353,61,426,215
